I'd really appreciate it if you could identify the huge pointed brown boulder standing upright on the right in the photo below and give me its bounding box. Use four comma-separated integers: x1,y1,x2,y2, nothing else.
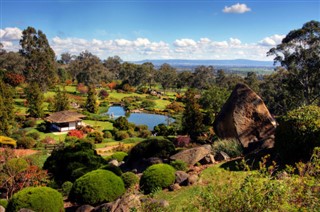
213,84,276,150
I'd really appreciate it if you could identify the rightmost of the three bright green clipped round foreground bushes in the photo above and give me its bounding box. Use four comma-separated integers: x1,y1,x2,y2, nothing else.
140,164,175,194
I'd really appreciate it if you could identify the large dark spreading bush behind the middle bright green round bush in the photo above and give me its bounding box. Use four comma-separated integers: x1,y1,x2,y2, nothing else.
44,142,106,183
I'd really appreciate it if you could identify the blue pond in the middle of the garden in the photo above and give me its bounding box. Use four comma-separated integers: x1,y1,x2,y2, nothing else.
107,106,174,130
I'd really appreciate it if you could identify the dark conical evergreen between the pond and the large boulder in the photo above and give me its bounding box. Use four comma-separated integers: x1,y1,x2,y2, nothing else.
182,89,204,141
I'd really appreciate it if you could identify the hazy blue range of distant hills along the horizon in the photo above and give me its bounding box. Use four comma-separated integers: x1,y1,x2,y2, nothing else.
133,59,273,67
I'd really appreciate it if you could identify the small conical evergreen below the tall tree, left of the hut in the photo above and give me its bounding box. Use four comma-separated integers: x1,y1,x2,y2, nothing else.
25,82,44,118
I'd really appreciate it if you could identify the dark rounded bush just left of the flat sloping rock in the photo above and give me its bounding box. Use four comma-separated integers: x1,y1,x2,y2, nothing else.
128,138,175,162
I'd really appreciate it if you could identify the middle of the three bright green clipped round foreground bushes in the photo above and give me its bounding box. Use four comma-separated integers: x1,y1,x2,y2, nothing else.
69,169,125,205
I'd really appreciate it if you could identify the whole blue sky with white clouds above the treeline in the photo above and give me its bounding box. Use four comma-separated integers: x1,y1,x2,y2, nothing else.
0,0,320,61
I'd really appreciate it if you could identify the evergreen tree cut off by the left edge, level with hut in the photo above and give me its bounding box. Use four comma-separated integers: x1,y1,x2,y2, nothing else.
0,80,15,135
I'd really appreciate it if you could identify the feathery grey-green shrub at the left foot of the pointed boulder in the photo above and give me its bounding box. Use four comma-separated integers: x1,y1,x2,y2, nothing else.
212,139,243,158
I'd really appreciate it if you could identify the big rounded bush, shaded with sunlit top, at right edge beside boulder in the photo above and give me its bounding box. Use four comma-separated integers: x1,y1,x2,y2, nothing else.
275,106,320,163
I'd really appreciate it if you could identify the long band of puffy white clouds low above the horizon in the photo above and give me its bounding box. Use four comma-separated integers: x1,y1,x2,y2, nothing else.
0,28,284,61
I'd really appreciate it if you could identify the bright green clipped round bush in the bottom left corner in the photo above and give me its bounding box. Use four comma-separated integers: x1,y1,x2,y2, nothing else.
6,187,64,212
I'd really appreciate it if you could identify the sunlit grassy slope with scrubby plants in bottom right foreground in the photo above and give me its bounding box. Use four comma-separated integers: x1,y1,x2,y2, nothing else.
150,161,320,211
